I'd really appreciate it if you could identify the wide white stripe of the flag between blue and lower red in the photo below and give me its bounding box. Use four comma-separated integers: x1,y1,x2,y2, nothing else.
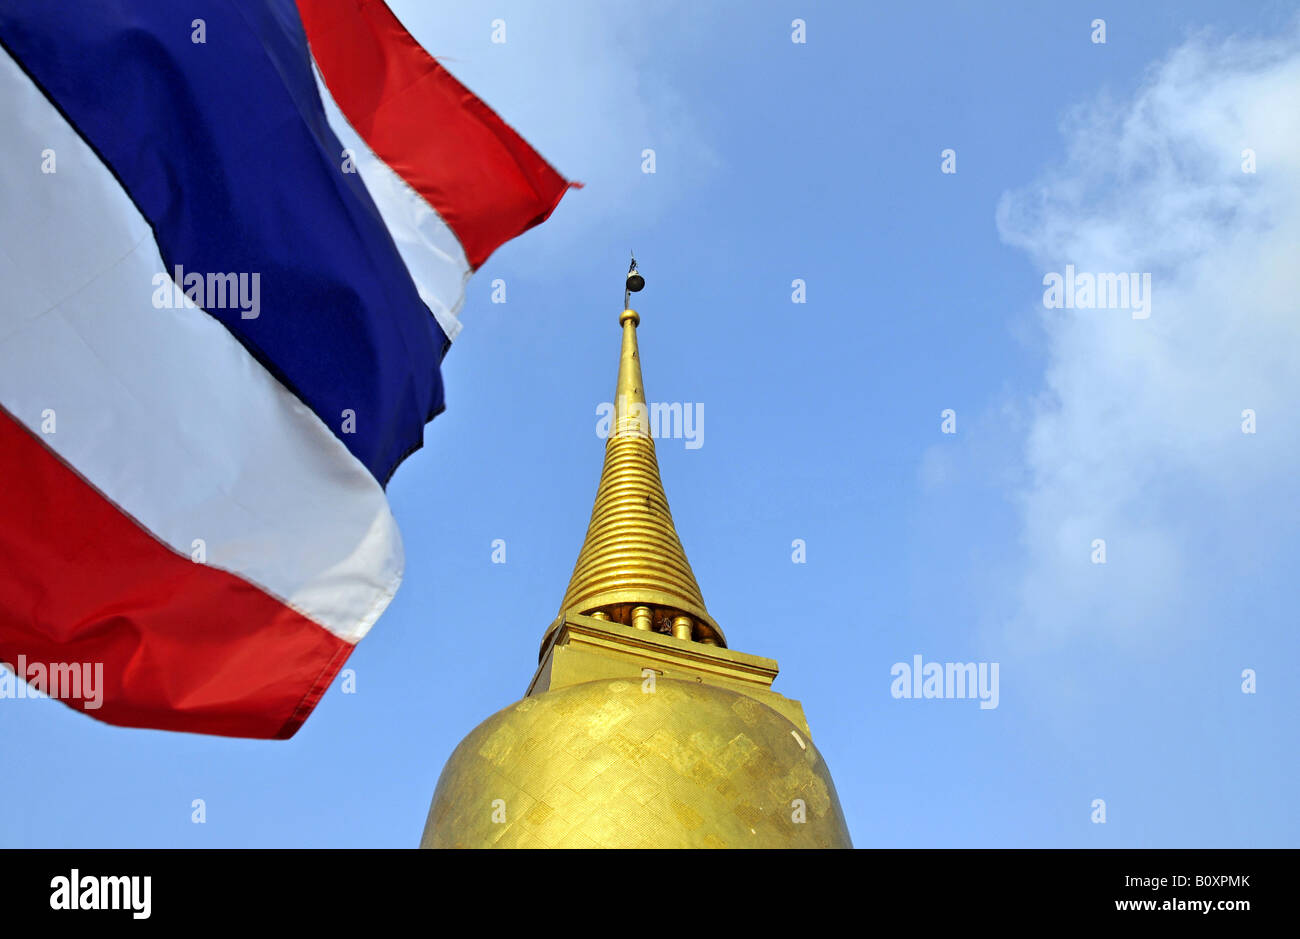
0,51,402,641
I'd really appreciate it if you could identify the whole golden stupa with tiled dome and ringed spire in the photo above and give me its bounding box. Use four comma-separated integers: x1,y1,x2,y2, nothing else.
420,261,852,848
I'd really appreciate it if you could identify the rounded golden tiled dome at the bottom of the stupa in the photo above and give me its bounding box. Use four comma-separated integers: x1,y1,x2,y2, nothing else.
423,679,849,848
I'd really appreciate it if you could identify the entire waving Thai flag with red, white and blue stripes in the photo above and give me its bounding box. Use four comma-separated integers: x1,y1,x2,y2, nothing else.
0,0,571,737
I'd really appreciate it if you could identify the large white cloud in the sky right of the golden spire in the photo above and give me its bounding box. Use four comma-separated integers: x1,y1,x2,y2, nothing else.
997,25,1300,644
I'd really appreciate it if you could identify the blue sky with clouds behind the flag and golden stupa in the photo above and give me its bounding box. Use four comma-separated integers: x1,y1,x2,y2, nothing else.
0,0,1300,847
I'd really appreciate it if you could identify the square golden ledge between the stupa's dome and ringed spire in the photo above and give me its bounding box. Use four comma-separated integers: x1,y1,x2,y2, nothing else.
524,611,811,737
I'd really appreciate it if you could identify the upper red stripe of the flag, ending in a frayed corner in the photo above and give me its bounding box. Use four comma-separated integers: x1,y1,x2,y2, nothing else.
298,0,581,268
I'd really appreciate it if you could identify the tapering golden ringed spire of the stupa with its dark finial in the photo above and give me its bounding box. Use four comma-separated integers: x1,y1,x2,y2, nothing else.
542,259,727,649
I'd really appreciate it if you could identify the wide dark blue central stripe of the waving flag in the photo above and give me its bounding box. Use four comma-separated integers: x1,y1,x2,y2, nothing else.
0,0,449,483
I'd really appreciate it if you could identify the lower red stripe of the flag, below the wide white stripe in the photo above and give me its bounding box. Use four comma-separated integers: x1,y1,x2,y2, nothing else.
0,408,352,739
